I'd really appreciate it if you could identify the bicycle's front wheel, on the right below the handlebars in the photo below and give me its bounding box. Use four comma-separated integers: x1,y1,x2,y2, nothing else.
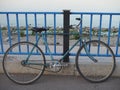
76,40,115,83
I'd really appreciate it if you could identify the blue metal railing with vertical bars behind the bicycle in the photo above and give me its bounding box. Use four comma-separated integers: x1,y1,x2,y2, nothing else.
0,12,120,56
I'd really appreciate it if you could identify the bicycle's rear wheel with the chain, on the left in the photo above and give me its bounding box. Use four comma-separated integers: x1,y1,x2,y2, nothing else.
3,42,45,84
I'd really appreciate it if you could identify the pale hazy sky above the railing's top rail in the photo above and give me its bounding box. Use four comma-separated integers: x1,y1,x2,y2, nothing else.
0,0,120,12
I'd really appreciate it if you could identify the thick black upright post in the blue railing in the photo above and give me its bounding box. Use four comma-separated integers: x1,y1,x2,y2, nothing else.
63,10,70,62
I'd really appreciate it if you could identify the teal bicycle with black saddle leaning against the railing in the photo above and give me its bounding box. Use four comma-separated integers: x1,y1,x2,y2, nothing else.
3,18,115,84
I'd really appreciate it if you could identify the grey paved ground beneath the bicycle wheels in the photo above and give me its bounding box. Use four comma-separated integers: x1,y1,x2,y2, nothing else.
0,75,120,90
